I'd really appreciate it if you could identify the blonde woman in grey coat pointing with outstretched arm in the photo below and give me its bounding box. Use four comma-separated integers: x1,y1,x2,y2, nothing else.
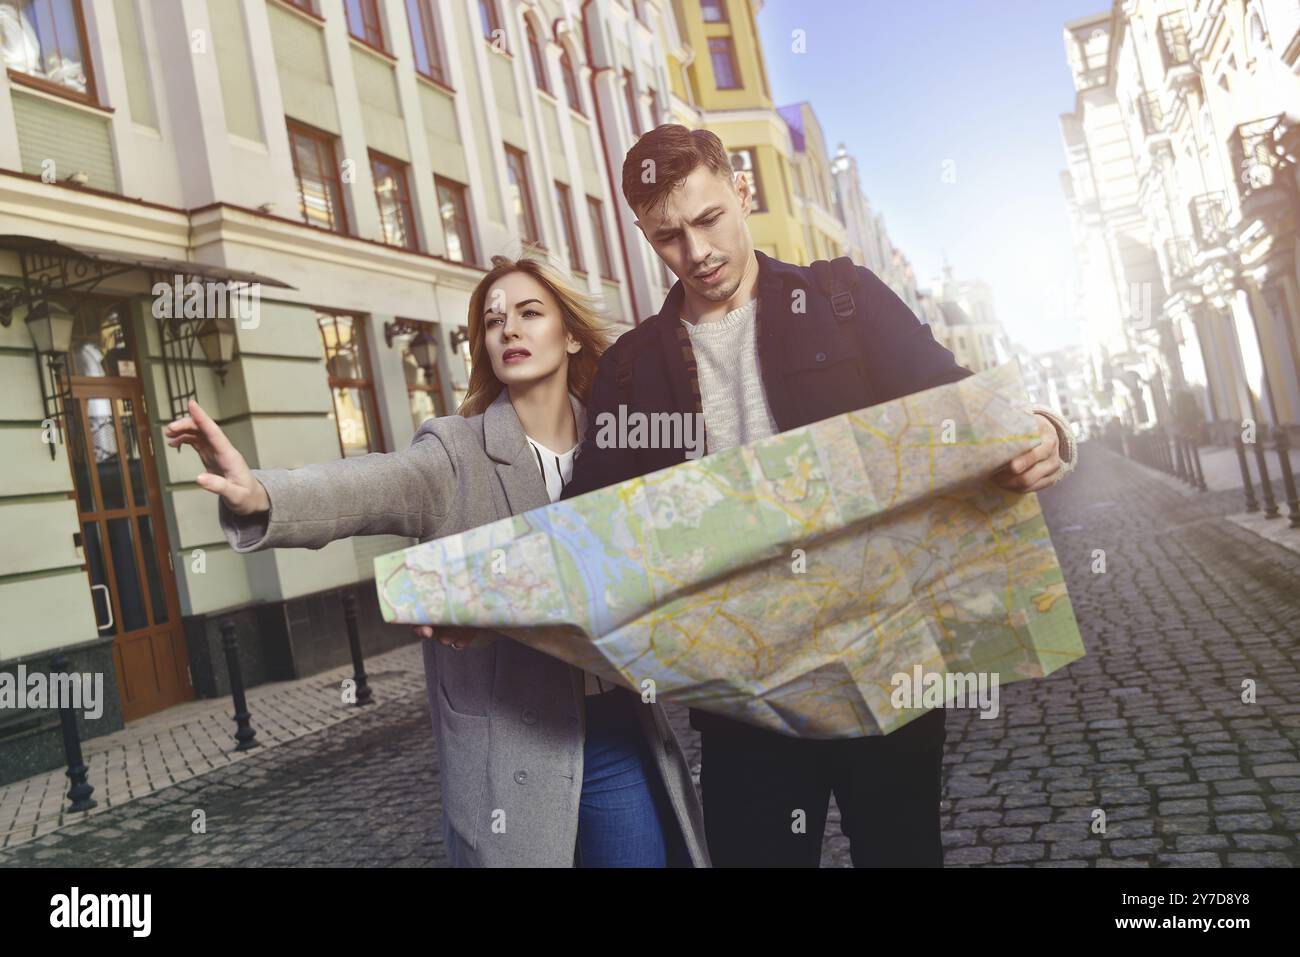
164,256,709,866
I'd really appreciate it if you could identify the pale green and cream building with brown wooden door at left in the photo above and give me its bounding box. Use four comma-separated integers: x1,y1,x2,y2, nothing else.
0,0,681,778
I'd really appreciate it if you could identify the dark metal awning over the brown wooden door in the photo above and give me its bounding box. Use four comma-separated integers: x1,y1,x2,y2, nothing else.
0,235,294,290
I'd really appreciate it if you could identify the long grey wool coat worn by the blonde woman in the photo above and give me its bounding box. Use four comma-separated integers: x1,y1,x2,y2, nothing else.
221,389,709,867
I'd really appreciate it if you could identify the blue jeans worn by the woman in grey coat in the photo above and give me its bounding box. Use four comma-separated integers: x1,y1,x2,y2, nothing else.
573,689,670,867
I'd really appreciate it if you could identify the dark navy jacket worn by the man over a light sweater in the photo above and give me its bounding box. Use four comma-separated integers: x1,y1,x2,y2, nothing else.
560,250,974,732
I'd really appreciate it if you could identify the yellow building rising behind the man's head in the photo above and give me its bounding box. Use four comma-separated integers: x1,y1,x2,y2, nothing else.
670,0,800,263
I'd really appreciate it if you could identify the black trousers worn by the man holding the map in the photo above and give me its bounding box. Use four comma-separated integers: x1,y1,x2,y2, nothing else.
701,709,946,867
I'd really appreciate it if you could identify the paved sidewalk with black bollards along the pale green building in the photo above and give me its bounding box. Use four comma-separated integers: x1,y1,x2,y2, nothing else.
0,642,425,848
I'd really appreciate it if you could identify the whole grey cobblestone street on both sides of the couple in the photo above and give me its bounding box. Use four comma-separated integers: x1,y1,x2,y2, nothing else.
0,443,1300,867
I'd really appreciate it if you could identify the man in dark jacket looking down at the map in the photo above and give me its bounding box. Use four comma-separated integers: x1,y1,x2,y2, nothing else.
563,125,1075,867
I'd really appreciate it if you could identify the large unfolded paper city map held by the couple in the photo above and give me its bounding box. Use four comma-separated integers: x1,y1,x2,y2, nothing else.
374,363,1083,737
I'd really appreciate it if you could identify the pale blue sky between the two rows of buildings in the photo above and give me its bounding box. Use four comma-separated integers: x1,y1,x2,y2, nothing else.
758,0,1110,351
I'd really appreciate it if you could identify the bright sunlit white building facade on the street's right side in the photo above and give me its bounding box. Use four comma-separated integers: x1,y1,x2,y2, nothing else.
1062,0,1300,442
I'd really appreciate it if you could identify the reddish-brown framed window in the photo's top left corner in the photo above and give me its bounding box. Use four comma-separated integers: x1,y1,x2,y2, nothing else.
0,0,95,100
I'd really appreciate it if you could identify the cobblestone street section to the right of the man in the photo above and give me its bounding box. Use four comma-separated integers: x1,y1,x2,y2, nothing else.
915,443,1300,867
